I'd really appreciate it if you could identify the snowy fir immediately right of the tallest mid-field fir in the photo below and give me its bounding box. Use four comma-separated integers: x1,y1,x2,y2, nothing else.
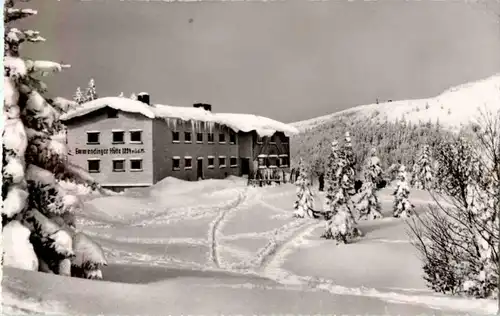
356,148,382,219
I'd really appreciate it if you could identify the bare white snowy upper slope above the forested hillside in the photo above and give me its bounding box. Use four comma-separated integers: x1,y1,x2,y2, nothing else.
291,74,500,131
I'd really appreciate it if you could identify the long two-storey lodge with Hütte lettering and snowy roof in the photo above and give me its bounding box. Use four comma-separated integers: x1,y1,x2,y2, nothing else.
61,93,298,190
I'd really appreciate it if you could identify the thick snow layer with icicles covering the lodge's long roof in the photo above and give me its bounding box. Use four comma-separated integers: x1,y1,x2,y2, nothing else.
61,97,299,136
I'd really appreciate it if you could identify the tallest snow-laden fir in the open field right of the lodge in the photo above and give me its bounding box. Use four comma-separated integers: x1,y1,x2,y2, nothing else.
322,141,361,243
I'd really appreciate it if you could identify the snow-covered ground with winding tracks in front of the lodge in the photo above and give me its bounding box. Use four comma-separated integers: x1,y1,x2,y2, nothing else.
2,177,496,315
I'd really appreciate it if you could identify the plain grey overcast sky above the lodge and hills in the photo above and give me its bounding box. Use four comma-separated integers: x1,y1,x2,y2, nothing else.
20,0,500,122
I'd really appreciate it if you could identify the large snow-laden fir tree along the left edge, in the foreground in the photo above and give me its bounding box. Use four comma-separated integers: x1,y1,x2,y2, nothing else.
2,0,107,278
